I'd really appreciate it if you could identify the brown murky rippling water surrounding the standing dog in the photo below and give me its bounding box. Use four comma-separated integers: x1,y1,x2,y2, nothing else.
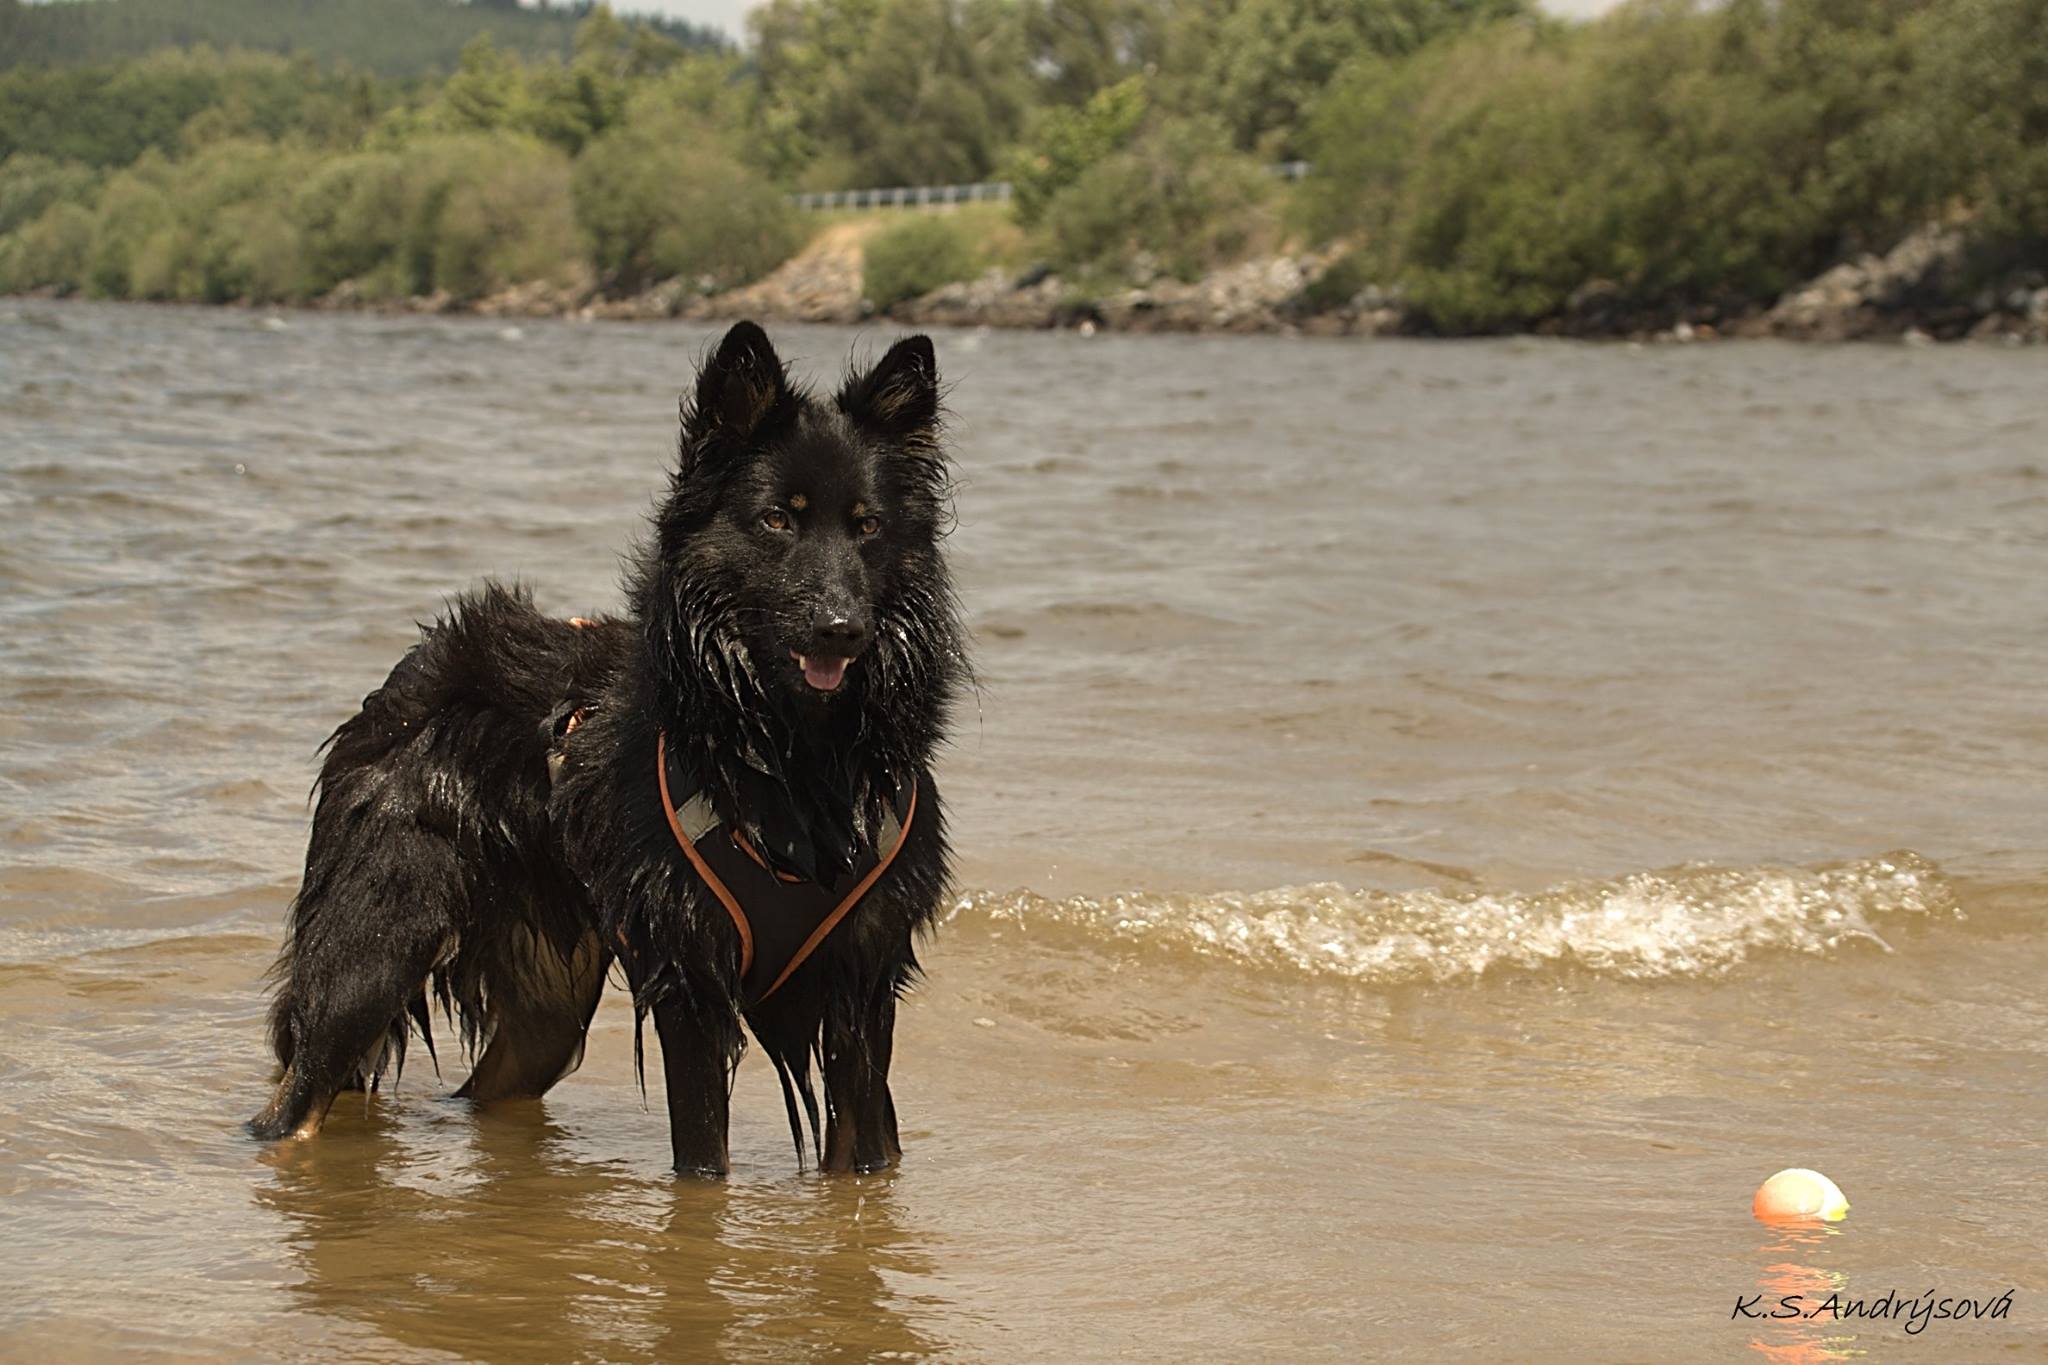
0,301,2048,1361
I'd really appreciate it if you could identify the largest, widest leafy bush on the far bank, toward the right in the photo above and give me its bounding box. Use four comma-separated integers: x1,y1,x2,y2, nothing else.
1305,0,1933,332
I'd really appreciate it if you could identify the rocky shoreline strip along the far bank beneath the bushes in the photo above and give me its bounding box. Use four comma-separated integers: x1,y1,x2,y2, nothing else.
264,221,2048,344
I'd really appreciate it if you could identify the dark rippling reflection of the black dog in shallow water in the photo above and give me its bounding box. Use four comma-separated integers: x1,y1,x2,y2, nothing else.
256,1099,938,1361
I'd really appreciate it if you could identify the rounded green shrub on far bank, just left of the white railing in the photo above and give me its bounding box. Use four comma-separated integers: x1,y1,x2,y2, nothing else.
571,123,803,293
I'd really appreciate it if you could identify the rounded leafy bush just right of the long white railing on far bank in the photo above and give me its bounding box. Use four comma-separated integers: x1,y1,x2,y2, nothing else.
1044,119,1274,278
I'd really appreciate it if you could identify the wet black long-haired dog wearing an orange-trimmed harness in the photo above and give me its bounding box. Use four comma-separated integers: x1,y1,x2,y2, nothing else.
250,323,965,1175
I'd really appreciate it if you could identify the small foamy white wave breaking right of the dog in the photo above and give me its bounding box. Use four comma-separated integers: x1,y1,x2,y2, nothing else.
954,851,1962,982
